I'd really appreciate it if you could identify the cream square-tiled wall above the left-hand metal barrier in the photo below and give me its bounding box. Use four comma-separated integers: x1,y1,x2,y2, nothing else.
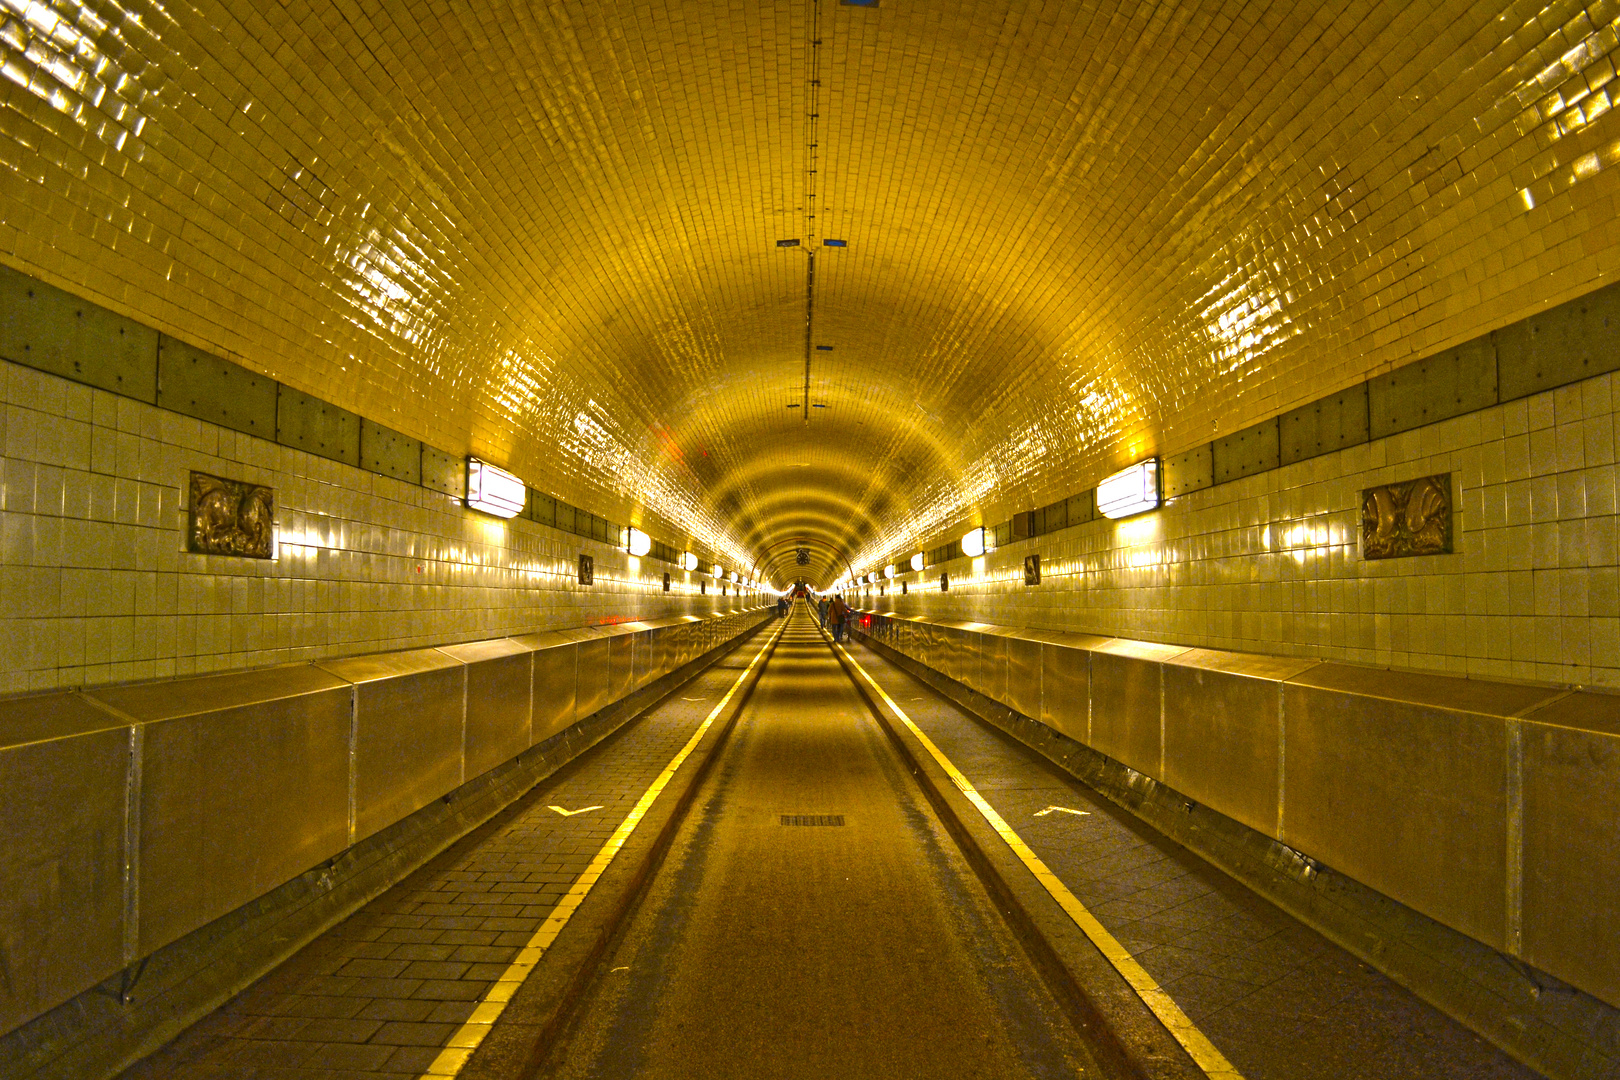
0,361,758,693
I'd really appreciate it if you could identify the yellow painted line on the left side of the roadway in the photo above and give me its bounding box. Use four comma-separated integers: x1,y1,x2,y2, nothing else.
418,623,786,1080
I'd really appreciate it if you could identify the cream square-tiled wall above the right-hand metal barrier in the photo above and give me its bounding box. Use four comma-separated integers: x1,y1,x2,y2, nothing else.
865,376,1620,687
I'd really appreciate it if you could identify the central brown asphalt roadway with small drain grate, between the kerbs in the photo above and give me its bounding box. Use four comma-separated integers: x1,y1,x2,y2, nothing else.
546,606,1102,1078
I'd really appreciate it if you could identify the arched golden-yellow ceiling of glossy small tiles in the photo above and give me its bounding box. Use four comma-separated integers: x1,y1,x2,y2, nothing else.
0,0,1620,592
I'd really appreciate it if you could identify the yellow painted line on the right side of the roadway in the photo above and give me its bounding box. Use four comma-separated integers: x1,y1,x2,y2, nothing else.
833,644,1243,1080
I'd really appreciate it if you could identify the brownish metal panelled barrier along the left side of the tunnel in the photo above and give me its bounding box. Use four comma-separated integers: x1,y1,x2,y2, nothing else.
0,607,771,1035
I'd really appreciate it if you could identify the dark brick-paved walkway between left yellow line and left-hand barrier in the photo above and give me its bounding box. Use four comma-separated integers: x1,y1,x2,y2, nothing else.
123,644,757,1080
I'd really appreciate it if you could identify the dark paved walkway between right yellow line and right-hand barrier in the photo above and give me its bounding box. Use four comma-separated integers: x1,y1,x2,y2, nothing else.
852,644,1537,1080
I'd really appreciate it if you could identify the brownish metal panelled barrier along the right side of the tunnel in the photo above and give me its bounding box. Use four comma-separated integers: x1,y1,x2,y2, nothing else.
855,612,1620,1006
